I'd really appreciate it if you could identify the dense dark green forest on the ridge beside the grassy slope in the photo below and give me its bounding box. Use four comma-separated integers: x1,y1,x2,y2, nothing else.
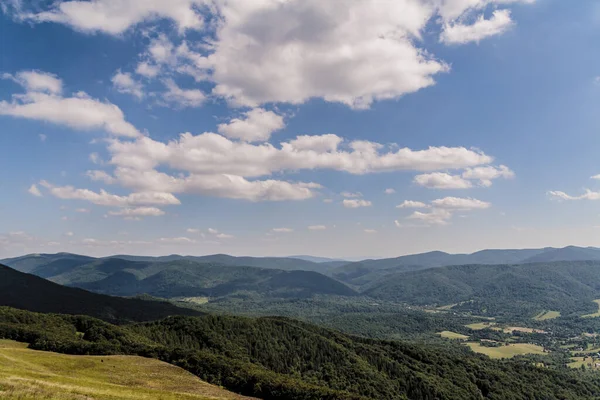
0,307,600,400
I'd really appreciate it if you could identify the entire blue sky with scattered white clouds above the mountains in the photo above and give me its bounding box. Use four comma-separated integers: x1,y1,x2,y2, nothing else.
0,0,600,258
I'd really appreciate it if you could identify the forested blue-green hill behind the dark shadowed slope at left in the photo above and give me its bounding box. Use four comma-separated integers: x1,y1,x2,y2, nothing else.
8,258,356,298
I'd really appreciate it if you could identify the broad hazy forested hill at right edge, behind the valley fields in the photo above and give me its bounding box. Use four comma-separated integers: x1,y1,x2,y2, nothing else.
364,261,600,316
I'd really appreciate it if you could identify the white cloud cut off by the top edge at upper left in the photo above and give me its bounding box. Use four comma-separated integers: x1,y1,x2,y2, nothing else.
23,0,204,35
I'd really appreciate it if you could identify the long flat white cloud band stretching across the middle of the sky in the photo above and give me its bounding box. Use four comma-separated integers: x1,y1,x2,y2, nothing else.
109,132,493,177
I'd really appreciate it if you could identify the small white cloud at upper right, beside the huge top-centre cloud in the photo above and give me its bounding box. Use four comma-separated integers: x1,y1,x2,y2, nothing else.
440,10,513,44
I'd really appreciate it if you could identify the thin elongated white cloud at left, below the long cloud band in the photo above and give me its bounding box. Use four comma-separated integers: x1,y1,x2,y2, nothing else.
40,181,181,207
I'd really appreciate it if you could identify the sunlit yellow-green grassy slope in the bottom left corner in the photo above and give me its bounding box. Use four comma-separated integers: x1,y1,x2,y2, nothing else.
0,340,254,400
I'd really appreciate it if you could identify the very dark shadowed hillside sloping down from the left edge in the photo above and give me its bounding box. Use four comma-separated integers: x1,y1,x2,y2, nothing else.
0,265,200,322
